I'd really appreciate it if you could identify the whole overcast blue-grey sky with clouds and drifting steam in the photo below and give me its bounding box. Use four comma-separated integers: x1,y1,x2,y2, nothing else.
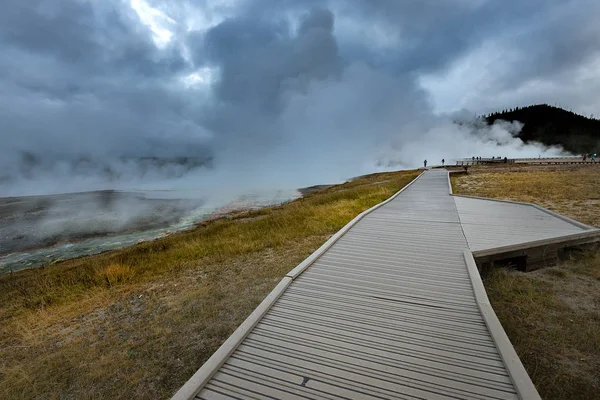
0,0,600,195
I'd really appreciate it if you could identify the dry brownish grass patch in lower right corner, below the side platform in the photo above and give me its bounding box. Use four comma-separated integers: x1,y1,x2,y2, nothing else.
484,254,600,400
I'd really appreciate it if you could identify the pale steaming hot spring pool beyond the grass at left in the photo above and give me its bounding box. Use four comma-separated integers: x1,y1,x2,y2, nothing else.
0,189,301,274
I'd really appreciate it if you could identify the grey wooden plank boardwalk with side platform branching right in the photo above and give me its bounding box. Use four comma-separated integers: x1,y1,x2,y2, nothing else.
174,170,596,399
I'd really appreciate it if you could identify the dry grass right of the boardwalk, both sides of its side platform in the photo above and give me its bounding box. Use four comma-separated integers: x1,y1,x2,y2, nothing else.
452,166,600,400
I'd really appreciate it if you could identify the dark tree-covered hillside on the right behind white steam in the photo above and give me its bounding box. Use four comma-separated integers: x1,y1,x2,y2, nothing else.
485,104,600,154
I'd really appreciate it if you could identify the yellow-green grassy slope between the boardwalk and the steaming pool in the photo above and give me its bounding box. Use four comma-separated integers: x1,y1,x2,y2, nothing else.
0,171,418,399
